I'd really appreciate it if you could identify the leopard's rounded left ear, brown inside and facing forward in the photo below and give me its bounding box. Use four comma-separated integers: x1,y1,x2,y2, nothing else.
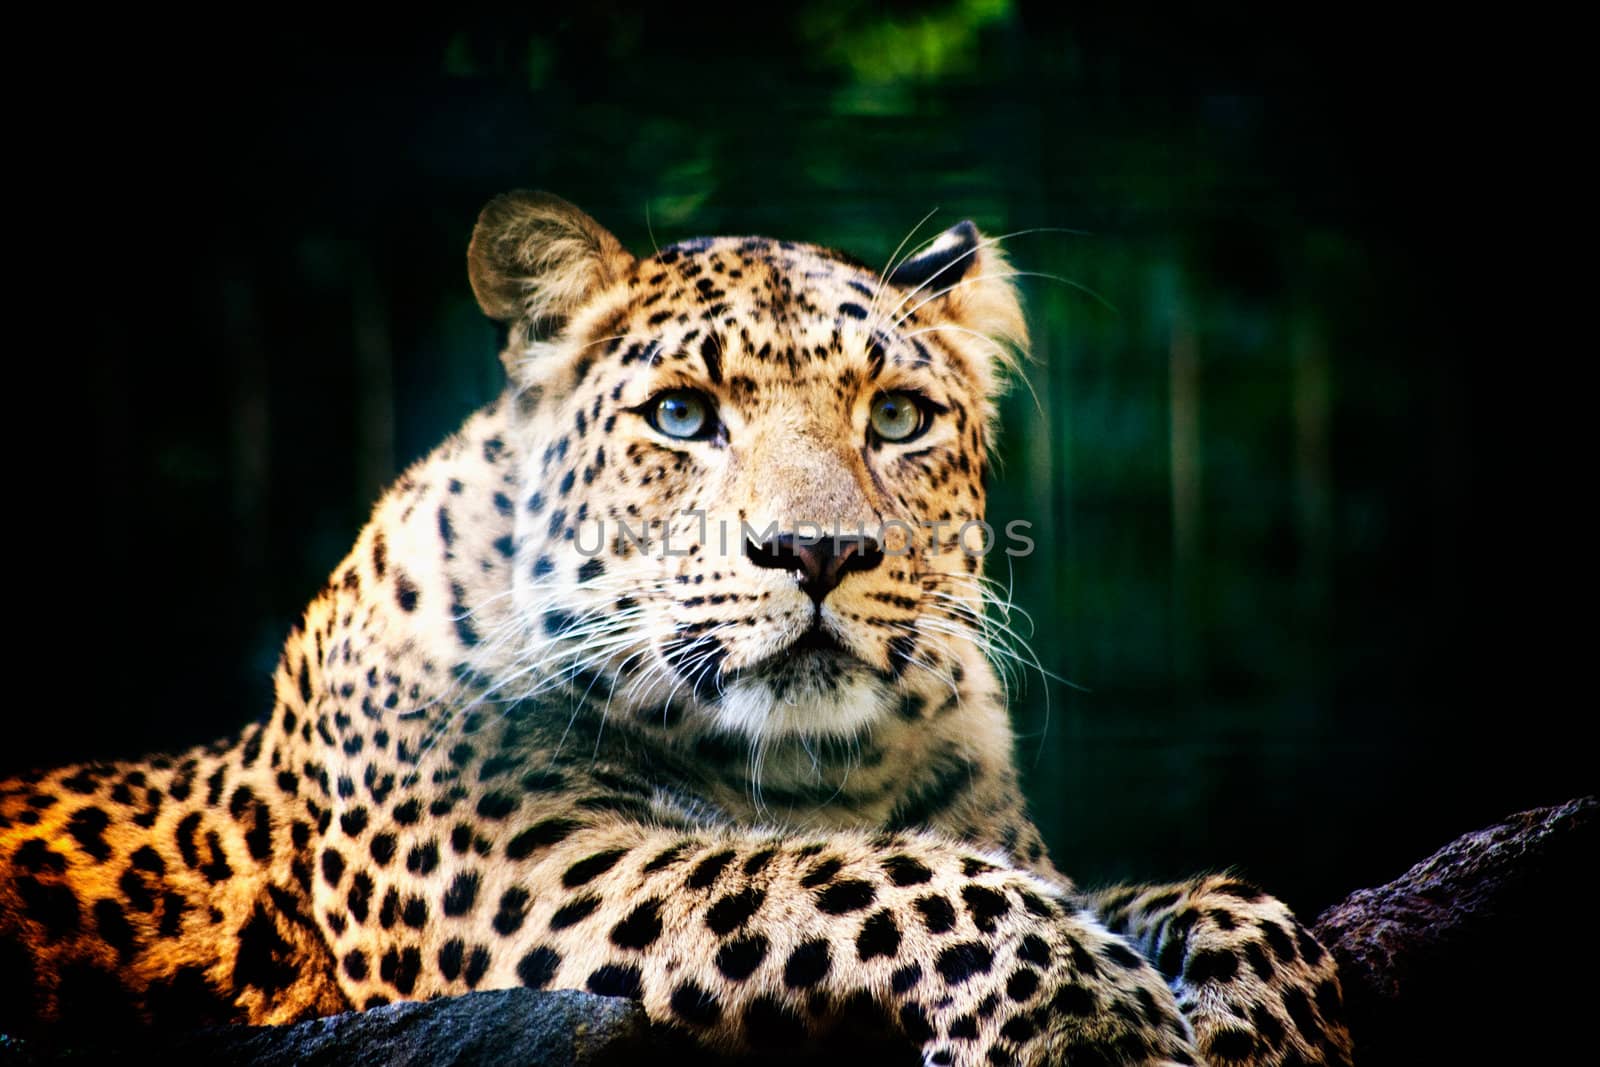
467,189,634,338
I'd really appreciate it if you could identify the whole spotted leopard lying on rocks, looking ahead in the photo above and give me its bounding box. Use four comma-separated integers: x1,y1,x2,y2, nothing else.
0,192,1352,1067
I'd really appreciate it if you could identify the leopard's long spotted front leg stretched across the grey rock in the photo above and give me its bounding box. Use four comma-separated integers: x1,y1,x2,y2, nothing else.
349,822,1197,1065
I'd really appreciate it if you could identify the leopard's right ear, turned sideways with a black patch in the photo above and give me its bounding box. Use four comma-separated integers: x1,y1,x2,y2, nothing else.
890,222,1027,387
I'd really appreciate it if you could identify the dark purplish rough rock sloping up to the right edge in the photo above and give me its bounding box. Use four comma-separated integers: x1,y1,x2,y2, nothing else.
1314,797,1600,1067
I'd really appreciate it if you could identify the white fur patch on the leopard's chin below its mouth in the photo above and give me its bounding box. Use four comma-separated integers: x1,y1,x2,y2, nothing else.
707,670,893,741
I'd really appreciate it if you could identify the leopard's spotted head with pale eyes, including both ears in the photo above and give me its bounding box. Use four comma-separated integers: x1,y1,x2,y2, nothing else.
472,195,1022,742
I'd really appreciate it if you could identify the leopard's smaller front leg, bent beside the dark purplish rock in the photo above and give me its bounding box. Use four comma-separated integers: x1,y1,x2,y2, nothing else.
1088,875,1350,1067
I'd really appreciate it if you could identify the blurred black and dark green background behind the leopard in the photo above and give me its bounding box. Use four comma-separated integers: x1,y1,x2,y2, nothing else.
18,0,1597,912
